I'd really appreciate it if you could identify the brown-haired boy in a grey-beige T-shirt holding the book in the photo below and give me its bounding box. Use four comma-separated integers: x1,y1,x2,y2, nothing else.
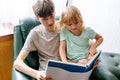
14,0,60,80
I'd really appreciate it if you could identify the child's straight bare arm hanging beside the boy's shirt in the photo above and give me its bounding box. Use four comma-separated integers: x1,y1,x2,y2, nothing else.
59,40,67,62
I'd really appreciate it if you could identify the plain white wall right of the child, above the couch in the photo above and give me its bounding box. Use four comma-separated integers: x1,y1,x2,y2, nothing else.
71,0,120,53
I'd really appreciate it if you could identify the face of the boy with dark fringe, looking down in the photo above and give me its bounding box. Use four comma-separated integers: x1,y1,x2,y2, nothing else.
37,13,55,31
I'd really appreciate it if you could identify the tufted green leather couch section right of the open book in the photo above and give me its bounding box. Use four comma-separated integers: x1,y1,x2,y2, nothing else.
91,52,120,80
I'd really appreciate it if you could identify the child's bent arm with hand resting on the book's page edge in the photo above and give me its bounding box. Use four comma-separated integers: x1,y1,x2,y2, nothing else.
89,33,103,55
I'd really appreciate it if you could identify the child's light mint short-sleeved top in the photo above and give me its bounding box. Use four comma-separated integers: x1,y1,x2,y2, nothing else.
60,27,96,62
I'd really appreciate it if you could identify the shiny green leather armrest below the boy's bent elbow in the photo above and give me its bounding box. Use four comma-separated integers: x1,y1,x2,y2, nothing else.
12,68,35,80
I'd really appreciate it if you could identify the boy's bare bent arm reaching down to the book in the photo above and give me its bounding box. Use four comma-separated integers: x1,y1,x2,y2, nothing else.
14,50,45,79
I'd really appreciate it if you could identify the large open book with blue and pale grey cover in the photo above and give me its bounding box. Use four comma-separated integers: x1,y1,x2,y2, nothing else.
46,50,101,80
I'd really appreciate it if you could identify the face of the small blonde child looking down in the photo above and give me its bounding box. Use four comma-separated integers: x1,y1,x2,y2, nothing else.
65,21,82,34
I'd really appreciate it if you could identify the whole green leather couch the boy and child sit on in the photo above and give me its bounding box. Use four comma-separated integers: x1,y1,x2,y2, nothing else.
12,17,120,80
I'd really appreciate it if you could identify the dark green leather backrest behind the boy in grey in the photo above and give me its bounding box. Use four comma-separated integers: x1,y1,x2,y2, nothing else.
13,18,40,69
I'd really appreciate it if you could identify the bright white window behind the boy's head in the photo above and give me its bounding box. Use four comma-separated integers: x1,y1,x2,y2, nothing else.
0,0,67,35
